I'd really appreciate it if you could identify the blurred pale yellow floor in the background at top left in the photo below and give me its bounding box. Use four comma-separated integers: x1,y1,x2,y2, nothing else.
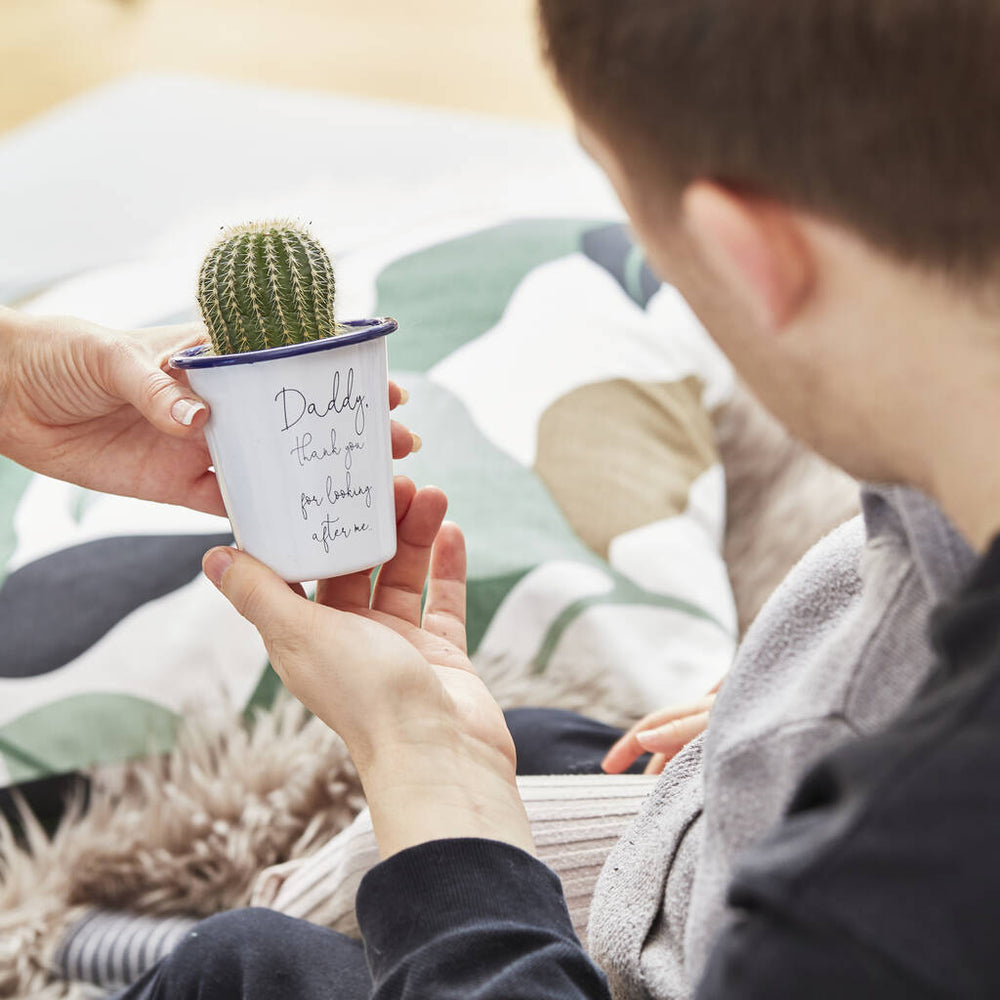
0,0,566,132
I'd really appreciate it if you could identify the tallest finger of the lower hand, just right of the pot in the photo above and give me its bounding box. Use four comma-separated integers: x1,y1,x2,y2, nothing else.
372,486,448,625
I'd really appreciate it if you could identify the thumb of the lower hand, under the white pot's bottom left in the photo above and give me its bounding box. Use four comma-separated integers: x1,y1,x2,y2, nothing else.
202,546,315,659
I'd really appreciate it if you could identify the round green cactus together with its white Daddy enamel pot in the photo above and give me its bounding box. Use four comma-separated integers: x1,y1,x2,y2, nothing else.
171,222,396,582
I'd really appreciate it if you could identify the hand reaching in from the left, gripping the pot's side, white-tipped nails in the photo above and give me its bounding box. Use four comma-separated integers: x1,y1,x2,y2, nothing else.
0,307,420,514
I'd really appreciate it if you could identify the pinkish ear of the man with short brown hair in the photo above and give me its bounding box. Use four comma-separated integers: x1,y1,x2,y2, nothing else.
681,181,815,331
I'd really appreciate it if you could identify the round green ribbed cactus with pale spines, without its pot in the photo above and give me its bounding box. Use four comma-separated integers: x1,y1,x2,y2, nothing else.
198,222,337,354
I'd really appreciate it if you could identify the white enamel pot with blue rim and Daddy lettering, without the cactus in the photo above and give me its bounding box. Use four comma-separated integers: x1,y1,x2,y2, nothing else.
170,319,396,583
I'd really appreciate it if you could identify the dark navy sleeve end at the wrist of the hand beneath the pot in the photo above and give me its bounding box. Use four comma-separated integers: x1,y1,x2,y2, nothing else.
357,839,610,1000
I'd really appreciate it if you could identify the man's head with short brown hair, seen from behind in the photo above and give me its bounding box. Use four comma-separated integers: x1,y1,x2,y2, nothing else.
539,0,1000,508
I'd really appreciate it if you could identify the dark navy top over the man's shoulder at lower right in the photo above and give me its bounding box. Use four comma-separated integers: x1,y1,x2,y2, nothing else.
697,543,1000,1000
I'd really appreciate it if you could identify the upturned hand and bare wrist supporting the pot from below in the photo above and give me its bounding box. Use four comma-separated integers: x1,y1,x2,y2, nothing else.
198,477,533,858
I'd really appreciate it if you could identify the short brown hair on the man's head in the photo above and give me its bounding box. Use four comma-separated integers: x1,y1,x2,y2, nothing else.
539,0,1000,277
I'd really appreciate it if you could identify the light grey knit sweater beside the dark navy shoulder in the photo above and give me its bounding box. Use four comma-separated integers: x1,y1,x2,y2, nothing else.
588,487,975,1000
